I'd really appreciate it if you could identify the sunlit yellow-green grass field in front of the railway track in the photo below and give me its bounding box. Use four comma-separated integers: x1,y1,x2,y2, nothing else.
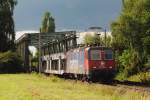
0,74,150,100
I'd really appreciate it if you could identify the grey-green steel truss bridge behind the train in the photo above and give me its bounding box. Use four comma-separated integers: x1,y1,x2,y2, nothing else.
15,31,77,71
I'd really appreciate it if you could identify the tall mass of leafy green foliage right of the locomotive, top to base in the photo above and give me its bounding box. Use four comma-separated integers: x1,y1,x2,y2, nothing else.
111,0,150,77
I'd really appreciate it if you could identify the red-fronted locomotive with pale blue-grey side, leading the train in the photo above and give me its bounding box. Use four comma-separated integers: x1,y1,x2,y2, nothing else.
66,47,116,80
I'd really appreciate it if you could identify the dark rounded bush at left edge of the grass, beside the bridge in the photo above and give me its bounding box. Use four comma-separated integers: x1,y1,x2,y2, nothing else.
0,51,24,73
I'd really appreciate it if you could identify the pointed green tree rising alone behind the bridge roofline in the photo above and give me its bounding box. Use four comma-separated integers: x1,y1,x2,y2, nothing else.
41,12,55,33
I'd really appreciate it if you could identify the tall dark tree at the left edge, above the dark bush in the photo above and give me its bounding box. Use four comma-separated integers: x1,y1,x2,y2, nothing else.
0,0,17,52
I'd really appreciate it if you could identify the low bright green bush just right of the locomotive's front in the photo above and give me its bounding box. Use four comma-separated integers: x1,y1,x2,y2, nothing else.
119,50,142,77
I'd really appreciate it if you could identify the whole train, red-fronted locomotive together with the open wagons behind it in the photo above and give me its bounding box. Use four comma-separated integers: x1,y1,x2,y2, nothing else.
41,46,116,80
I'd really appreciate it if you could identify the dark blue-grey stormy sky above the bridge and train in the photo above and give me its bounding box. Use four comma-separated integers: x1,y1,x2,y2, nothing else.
14,0,122,31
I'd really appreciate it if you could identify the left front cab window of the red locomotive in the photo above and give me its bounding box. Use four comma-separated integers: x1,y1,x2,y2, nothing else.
90,50,101,60
